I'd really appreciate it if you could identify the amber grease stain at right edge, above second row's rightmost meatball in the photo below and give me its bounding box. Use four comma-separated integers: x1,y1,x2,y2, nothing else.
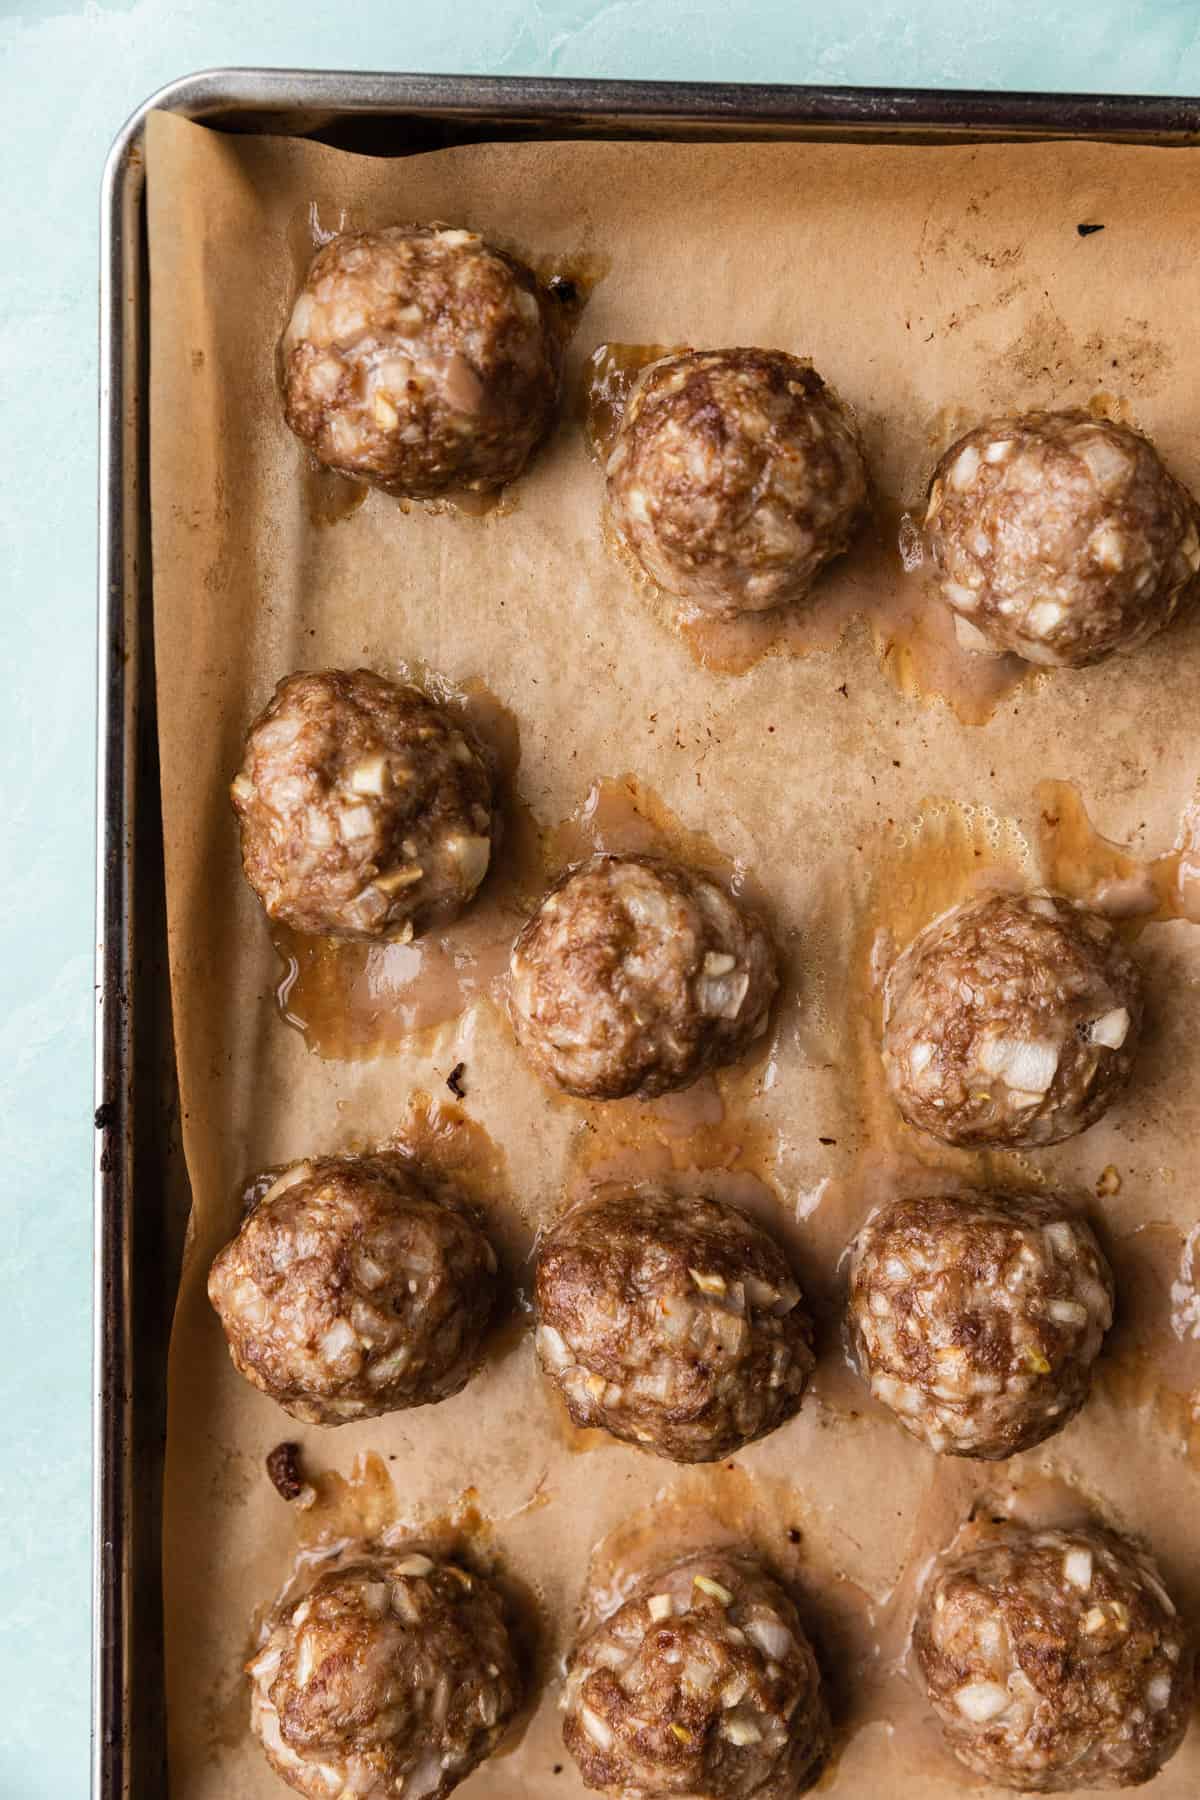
1034,781,1200,936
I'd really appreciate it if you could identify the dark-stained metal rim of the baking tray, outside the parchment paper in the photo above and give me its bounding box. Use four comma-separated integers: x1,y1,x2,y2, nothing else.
92,68,1200,1800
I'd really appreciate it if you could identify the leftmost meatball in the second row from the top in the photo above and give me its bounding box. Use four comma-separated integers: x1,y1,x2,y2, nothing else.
232,670,498,941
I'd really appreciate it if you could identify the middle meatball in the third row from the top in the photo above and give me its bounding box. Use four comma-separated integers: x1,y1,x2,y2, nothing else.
536,1188,813,1463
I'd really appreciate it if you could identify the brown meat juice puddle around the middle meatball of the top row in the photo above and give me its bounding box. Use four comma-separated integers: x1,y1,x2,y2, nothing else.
579,344,1040,725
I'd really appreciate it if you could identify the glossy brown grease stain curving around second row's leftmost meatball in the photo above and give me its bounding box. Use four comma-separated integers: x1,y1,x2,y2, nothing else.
272,670,540,1062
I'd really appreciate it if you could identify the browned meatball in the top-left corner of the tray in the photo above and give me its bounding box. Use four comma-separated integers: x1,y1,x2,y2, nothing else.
281,225,561,497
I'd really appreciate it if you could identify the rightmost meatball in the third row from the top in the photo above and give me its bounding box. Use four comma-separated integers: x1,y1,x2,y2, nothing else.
849,1193,1114,1458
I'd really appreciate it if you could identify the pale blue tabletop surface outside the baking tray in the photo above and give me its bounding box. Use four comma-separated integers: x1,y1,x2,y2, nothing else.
0,0,1200,1800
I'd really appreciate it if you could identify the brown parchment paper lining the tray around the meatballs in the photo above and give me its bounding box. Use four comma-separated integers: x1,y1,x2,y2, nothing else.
142,115,1200,1800
